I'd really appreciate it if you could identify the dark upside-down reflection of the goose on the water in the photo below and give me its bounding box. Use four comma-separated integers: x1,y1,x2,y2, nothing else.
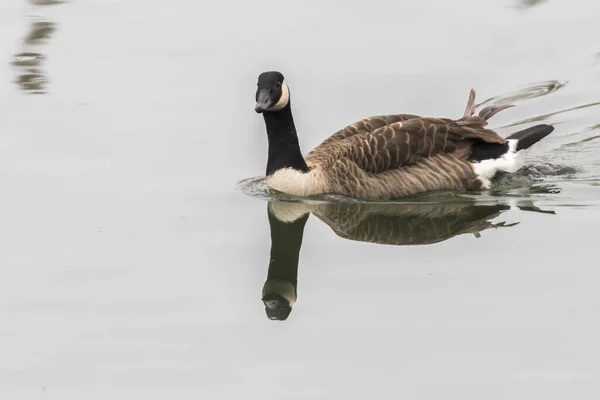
262,201,554,321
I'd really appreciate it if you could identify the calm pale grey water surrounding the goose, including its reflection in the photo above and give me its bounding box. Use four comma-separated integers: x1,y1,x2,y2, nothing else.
0,0,600,400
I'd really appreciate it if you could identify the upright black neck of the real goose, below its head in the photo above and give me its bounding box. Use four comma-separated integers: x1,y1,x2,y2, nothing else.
263,102,308,175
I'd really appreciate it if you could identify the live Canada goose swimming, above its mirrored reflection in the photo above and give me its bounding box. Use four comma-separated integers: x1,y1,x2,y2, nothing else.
255,71,554,200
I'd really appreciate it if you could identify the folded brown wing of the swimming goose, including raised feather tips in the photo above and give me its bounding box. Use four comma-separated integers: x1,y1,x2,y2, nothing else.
305,90,509,174
